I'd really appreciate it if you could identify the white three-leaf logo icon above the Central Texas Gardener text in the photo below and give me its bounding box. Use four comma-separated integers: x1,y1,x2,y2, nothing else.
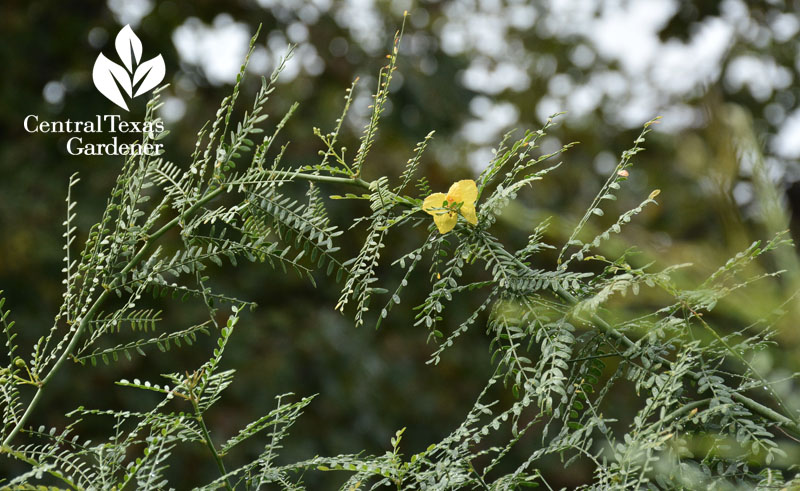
92,25,166,111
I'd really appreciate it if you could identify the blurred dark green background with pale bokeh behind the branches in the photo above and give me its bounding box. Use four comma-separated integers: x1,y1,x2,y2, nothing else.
0,0,800,486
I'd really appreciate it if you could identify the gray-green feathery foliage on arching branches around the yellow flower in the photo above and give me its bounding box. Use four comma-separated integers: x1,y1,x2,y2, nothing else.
0,27,800,489
